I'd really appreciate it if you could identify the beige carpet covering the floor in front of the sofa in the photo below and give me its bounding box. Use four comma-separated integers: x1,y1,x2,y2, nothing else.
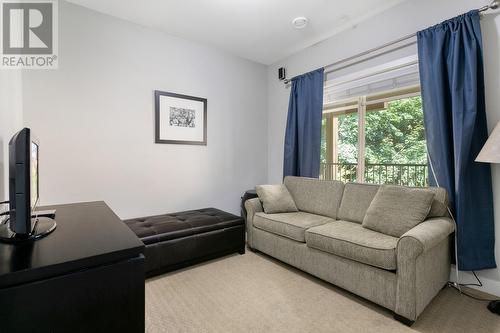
146,251,500,333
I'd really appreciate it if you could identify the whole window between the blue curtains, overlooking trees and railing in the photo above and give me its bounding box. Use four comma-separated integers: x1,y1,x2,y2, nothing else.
320,85,428,186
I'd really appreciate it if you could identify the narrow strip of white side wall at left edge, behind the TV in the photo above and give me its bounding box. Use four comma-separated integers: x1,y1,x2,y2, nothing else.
0,70,23,201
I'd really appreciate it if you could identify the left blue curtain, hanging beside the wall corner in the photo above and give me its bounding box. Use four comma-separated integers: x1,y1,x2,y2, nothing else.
283,68,324,178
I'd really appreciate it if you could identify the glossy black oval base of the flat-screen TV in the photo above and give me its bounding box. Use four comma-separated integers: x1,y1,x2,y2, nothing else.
0,216,57,243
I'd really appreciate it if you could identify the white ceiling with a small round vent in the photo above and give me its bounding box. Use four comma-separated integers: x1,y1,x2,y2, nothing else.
69,0,404,65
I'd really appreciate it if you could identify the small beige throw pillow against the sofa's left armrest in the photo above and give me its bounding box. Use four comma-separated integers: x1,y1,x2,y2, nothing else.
255,184,298,214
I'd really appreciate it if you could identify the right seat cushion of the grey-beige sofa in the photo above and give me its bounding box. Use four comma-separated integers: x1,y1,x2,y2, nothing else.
305,221,398,270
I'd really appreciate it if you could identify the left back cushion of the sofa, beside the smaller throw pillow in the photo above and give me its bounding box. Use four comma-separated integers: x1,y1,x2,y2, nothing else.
284,176,344,219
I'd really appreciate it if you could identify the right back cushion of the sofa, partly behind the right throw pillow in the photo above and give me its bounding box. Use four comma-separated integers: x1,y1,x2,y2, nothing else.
337,183,380,223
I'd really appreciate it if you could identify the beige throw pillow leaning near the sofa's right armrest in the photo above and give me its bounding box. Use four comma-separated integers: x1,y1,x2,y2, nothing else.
362,185,434,237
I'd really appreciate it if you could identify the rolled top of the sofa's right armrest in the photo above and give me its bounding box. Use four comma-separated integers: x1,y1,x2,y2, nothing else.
397,217,455,259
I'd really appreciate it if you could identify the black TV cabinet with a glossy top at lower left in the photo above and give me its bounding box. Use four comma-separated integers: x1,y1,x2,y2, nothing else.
0,201,145,333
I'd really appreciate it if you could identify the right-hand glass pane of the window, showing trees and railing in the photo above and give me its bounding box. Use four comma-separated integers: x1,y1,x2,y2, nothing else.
365,88,428,186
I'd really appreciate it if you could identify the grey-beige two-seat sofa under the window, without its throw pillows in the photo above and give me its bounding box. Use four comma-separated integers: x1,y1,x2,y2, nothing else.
245,177,454,325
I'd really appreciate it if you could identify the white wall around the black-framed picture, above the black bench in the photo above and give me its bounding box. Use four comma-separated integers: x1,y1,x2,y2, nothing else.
23,2,267,218
